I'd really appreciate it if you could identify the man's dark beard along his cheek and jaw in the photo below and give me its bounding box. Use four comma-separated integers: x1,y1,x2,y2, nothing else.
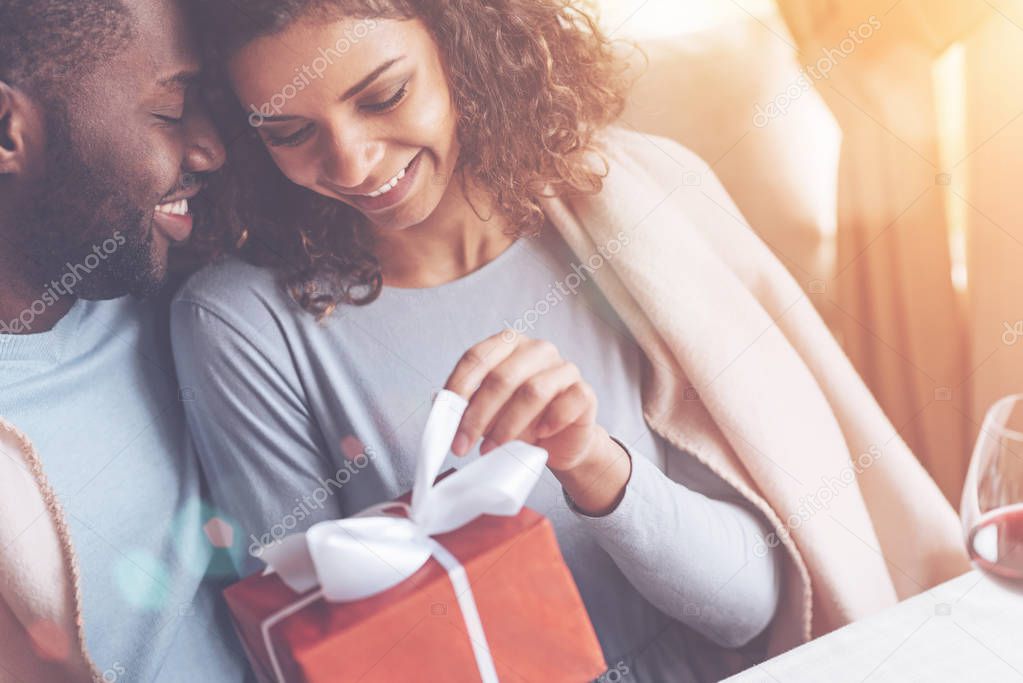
15,109,166,300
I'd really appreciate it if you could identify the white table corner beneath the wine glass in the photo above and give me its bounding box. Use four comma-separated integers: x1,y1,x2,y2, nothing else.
727,571,1023,683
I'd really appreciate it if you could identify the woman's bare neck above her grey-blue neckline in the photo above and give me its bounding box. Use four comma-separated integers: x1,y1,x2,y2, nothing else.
376,174,516,288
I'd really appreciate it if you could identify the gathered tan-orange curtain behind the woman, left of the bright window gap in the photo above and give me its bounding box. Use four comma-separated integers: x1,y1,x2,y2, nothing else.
779,0,982,503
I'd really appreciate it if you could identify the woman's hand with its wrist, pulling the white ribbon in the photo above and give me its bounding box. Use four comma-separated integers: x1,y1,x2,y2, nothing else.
444,332,632,514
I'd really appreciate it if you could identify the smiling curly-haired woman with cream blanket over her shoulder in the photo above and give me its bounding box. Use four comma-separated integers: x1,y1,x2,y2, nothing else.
173,0,962,681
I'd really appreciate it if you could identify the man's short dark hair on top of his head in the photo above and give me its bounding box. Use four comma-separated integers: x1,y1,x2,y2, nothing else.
0,0,135,98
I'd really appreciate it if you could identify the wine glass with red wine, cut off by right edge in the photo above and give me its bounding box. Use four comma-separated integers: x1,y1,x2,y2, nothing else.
960,394,1023,591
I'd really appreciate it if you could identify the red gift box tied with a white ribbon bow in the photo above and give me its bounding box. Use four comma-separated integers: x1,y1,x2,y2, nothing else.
225,482,607,683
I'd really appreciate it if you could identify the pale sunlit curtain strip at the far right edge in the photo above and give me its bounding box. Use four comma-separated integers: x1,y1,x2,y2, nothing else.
952,6,1023,474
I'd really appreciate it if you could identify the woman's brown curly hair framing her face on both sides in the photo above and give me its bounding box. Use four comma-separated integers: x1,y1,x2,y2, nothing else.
188,0,627,318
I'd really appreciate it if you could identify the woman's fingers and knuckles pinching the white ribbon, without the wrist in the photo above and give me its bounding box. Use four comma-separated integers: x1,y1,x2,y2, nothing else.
445,332,597,470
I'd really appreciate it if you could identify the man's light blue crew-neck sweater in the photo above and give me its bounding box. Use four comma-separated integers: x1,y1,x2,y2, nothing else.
0,299,248,683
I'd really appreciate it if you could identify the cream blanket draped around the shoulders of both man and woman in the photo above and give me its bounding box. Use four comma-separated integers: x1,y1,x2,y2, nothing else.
0,124,968,681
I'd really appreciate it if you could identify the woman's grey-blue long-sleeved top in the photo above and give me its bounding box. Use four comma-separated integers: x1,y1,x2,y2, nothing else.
172,226,780,682
